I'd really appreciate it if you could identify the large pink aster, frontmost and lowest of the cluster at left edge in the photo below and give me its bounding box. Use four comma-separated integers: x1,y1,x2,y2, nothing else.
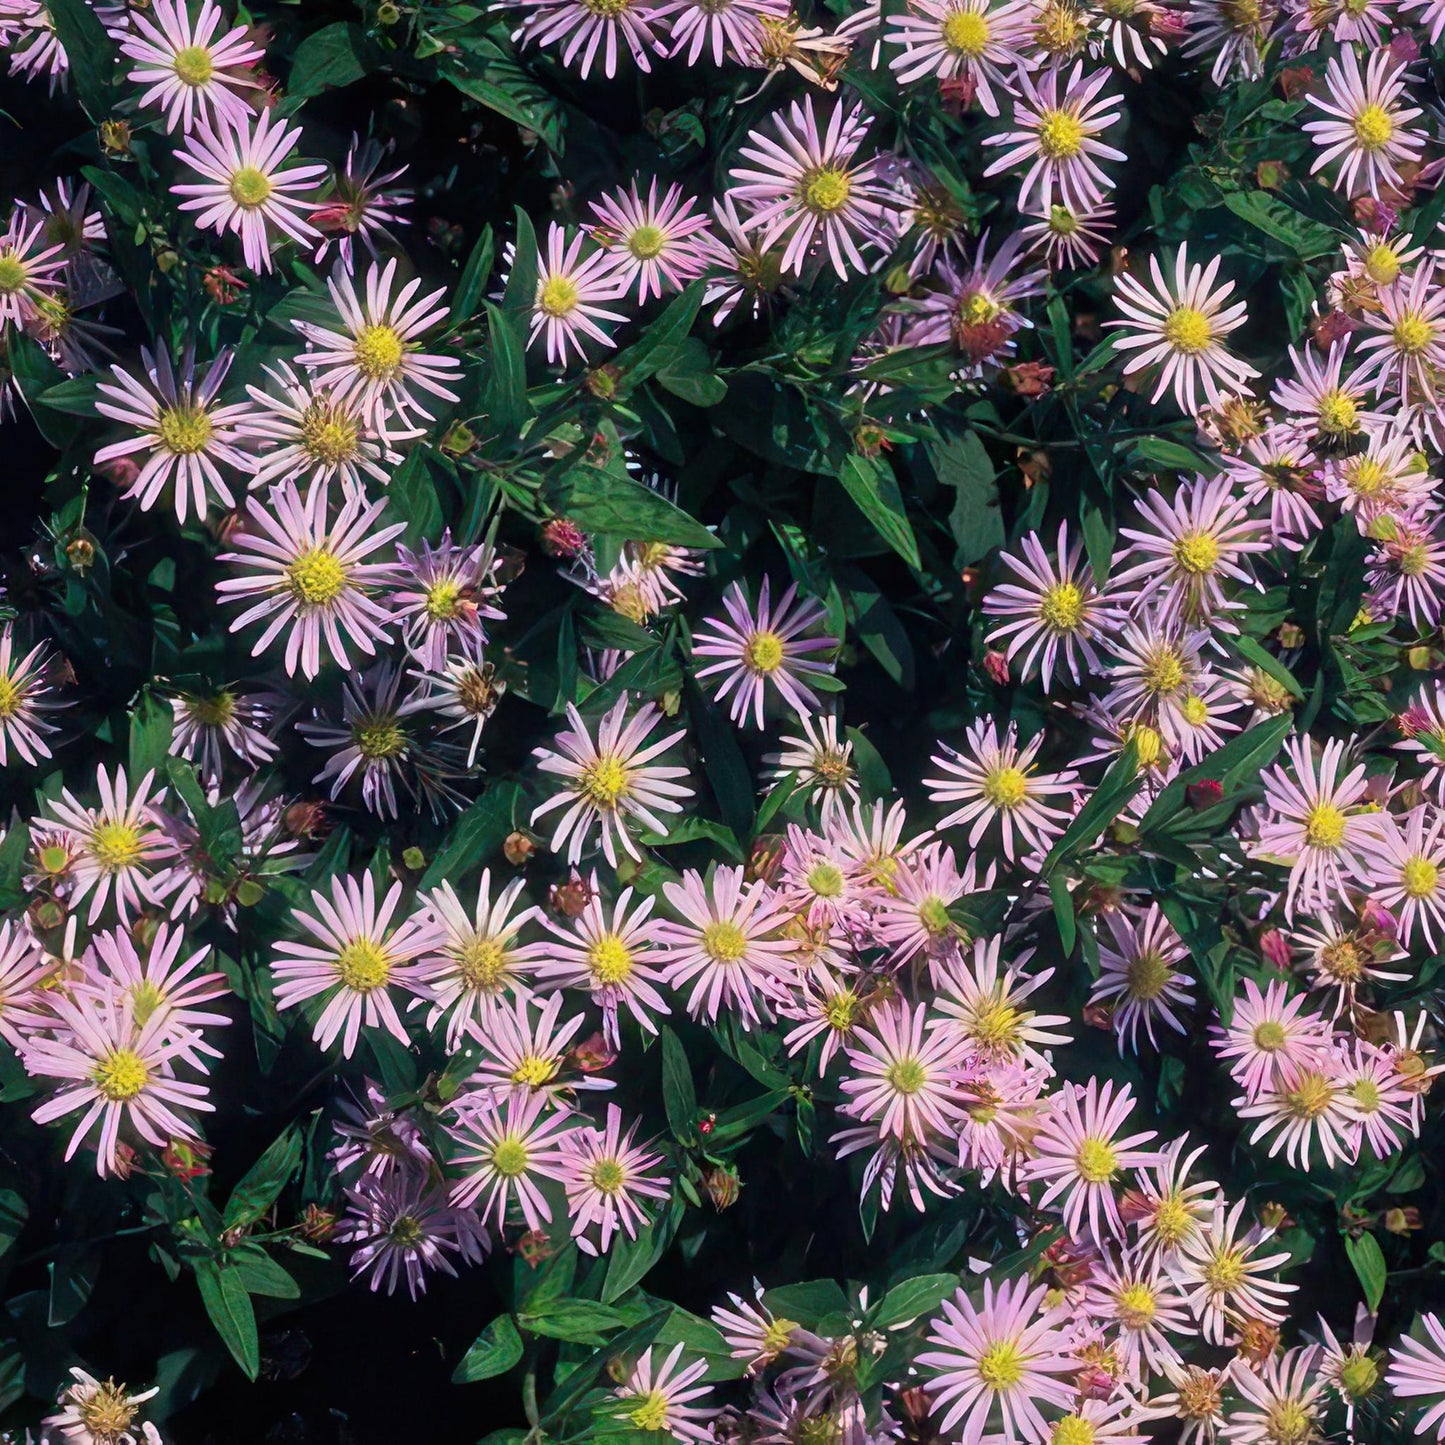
22,993,215,1178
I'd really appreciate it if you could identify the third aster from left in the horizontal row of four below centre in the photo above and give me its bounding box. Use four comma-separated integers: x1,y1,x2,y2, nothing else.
523,873,672,1049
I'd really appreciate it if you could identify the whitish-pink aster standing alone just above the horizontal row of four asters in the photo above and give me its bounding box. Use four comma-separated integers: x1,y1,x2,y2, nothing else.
532,695,694,867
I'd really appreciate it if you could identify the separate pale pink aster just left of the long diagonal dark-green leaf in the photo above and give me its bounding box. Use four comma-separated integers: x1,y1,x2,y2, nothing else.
923,718,1078,863
